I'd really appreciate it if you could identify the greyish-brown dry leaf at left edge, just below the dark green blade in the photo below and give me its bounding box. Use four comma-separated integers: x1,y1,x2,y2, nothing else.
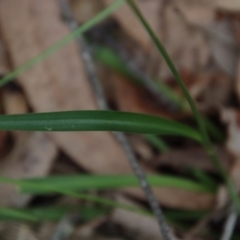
0,132,57,206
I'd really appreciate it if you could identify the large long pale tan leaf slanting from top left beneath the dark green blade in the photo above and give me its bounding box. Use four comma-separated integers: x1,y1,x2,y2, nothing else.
0,0,130,173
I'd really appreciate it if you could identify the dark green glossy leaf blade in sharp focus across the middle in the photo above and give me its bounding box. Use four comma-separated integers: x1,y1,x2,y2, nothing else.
0,110,201,142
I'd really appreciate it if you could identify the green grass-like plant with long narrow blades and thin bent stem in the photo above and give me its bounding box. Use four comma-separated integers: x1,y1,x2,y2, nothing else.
0,0,236,239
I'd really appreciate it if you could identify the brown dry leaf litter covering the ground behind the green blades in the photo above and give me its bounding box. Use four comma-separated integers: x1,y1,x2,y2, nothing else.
0,0,240,240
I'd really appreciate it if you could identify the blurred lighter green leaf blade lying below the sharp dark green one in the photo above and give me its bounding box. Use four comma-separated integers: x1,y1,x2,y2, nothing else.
17,174,214,194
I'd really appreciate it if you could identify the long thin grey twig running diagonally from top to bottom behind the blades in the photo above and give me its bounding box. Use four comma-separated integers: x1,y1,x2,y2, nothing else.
58,0,172,240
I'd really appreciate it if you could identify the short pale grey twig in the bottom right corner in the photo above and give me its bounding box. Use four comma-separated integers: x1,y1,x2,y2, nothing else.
221,206,238,240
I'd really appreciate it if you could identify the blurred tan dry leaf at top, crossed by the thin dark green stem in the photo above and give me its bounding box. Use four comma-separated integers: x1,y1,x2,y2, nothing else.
105,0,210,79
